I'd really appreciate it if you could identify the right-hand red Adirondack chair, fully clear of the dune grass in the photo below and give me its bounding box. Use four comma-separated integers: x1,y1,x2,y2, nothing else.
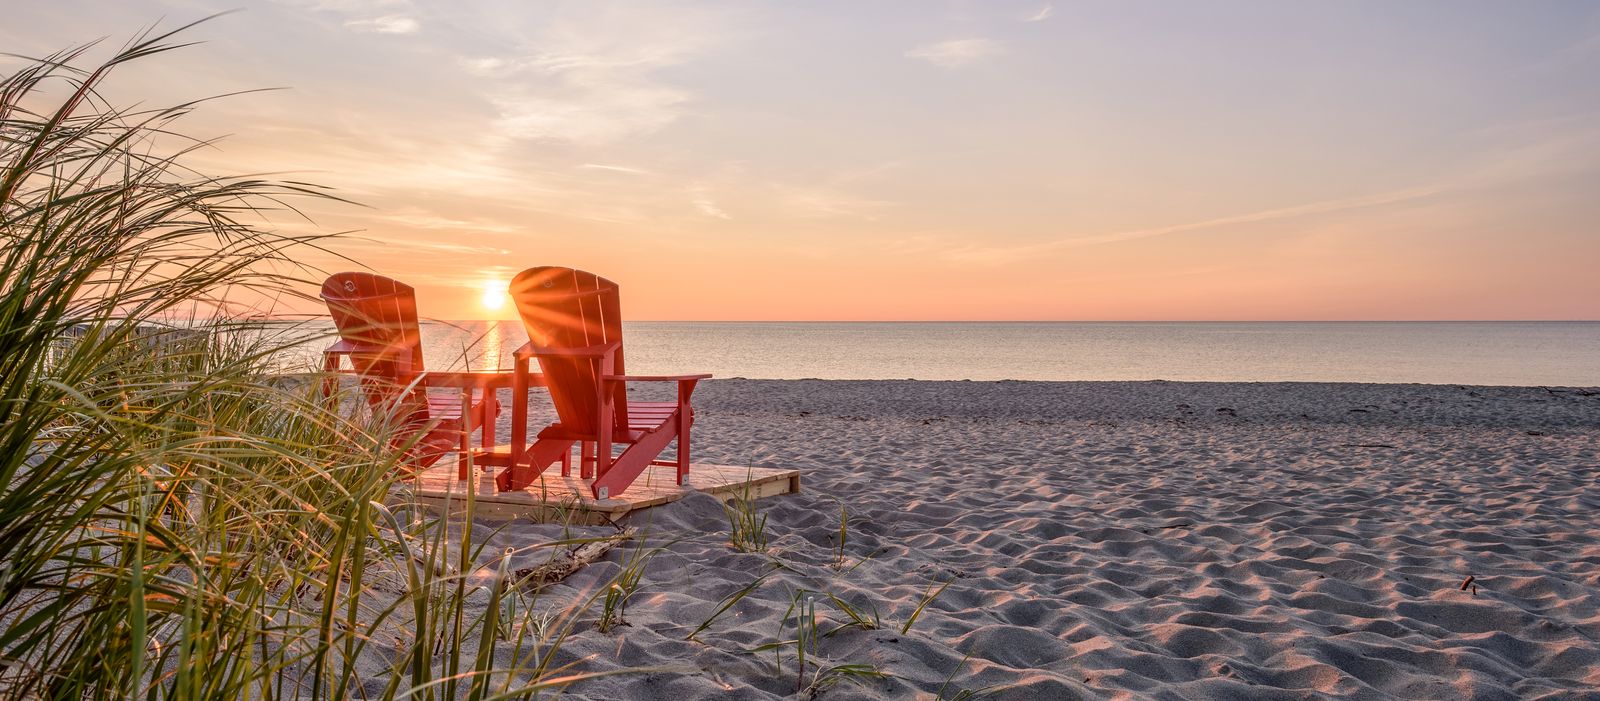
498,267,710,499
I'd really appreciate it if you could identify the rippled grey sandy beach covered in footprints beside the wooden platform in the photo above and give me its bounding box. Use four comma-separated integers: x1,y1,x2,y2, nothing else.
438,379,1600,699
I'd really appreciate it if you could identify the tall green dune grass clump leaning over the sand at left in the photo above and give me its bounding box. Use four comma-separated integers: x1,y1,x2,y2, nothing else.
0,27,630,699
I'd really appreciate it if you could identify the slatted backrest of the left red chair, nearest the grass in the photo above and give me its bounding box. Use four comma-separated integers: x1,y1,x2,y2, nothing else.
322,272,427,419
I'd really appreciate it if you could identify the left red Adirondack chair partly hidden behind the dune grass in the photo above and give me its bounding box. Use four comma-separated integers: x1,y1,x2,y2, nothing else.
322,272,512,480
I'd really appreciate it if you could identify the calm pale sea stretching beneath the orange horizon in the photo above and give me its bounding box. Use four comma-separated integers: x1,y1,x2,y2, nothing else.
281,322,1600,387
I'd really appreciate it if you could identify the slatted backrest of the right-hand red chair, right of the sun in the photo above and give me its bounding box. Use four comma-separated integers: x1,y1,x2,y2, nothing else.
510,266,627,435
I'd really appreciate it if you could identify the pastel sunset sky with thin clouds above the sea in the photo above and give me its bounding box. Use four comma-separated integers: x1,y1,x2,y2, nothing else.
0,0,1600,320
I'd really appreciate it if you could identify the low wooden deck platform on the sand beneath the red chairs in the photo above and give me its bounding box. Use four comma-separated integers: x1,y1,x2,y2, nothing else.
397,456,800,523
